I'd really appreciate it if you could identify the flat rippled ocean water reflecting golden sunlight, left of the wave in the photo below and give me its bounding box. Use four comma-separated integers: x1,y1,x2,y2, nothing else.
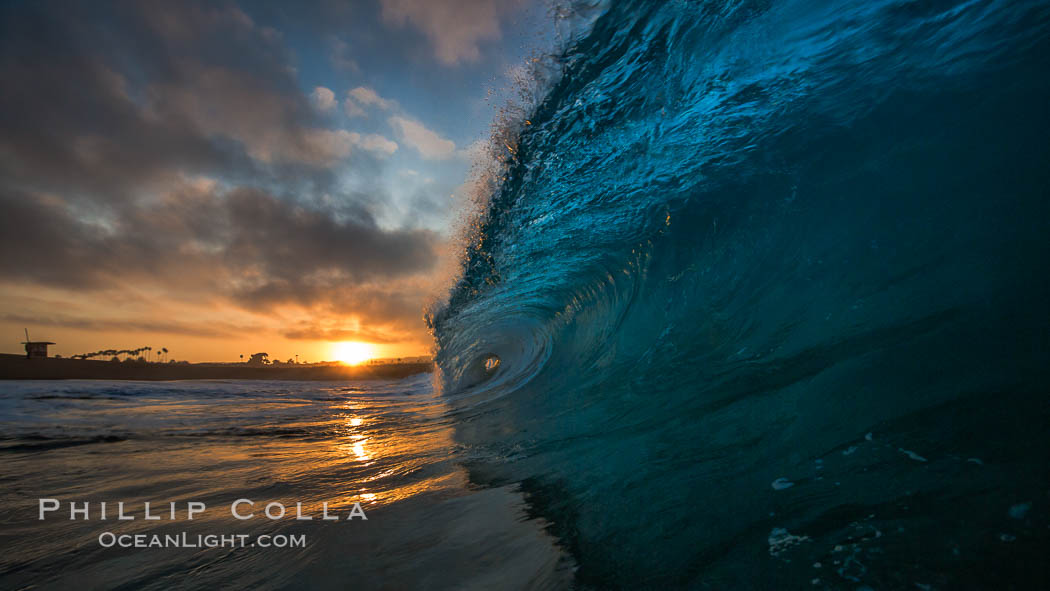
0,375,573,590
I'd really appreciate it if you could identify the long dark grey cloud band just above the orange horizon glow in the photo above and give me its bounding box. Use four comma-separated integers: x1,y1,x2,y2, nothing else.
0,187,436,318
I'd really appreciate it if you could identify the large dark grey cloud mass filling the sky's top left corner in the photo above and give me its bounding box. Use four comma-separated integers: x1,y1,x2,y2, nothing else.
0,2,409,202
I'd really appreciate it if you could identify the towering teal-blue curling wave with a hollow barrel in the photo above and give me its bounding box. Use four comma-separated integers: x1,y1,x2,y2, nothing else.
431,0,1050,589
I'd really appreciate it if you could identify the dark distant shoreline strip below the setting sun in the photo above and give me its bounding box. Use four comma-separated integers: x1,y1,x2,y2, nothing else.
0,354,434,381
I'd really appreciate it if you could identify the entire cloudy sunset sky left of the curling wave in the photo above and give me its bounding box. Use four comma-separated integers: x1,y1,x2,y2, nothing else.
0,0,548,361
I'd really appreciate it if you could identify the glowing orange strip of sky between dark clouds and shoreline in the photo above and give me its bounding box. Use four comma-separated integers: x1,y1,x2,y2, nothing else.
0,287,433,362
